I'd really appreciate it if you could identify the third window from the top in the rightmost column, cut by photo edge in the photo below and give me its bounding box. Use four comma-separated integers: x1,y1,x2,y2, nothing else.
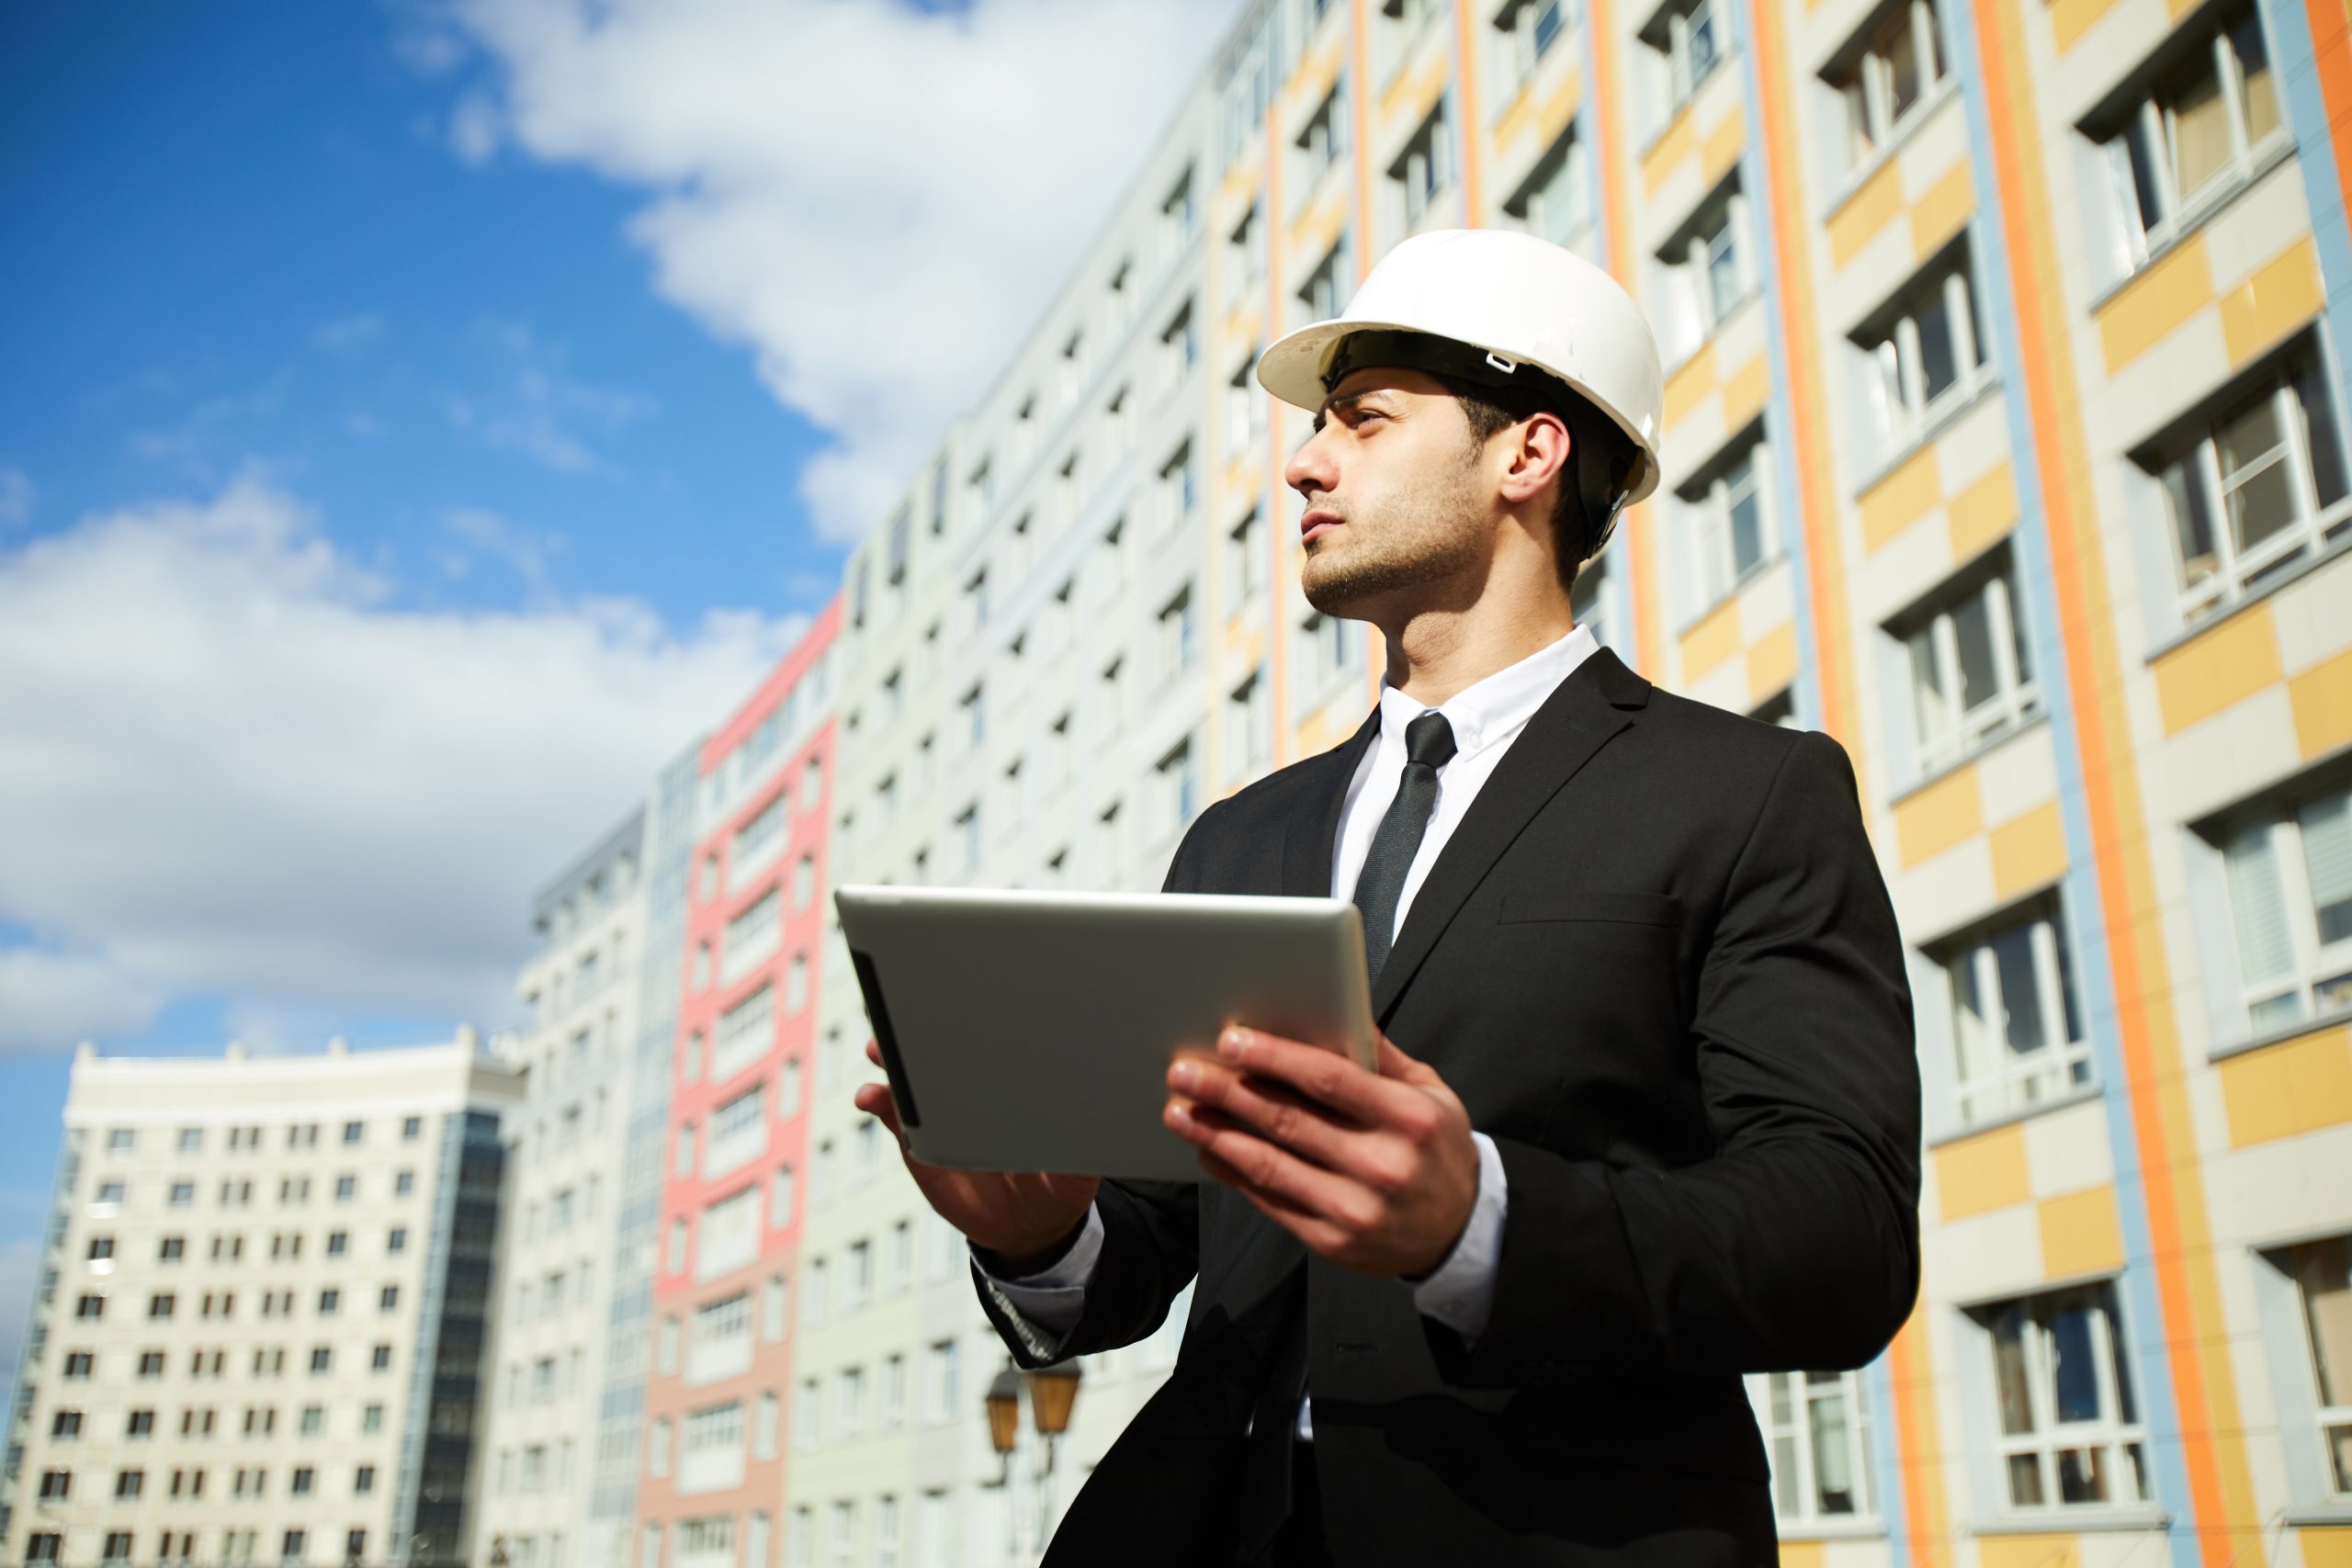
2222,783,2352,1034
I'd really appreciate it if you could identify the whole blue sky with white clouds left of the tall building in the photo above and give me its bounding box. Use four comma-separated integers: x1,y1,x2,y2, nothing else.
0,0,1235,1419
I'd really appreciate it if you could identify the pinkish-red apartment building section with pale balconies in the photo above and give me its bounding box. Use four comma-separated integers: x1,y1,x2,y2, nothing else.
638,604,840,1568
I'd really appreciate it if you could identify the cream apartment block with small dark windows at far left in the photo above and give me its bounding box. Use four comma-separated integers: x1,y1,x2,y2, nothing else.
0,1030,522,1565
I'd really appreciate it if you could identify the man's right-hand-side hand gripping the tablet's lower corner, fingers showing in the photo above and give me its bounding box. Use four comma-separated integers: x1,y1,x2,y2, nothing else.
1162,1027,1477,1277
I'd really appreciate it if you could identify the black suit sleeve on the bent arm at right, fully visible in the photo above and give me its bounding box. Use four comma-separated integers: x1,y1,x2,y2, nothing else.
1430,733,1919,1387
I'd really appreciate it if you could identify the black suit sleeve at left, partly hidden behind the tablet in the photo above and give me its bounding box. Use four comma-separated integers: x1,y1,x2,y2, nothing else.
971,807,1216,1368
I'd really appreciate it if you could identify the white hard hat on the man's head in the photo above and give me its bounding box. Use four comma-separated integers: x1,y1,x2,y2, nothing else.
1259,228,1663,536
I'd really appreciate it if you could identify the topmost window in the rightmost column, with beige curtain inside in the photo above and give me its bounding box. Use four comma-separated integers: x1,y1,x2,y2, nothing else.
2100,5,2286,273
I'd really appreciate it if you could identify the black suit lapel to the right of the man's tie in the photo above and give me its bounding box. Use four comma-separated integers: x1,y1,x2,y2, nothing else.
1363,649,1649,1027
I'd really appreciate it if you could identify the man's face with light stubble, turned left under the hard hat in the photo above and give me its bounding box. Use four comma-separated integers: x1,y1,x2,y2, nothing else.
1282,367,1494,618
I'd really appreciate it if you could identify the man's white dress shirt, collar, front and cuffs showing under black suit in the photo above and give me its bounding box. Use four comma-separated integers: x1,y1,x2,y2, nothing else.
974,626,1600,1438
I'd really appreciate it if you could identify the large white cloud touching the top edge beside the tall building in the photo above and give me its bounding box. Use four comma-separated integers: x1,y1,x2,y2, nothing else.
447,0,1235,541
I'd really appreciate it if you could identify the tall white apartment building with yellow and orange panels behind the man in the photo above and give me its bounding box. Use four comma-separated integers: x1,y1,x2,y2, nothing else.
783,0,2352,1565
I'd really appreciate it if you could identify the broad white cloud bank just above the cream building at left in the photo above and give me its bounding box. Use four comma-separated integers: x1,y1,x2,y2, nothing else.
0,478,797,1051
